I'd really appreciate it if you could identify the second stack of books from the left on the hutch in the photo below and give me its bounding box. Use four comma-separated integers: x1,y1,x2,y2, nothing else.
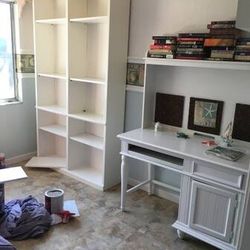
176,33,207,60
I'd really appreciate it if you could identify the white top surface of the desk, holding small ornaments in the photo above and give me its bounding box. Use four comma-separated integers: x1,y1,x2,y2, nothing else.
118,128,250,172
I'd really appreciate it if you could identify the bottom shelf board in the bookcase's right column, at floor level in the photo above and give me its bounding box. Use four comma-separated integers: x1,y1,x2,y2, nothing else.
58,166,104,190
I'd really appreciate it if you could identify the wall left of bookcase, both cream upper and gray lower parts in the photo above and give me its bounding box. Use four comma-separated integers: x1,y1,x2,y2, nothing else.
0,1,36,158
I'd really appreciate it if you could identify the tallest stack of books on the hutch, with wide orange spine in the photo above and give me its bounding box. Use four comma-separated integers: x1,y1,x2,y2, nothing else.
204,21,236,61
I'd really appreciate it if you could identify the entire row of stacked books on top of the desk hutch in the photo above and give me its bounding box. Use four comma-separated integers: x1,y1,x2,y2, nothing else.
147,21,250,62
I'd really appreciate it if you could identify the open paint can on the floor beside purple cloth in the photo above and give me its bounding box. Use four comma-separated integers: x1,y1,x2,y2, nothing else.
45,188,64,214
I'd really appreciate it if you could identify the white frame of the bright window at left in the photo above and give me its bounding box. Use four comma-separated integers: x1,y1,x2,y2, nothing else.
0,0,19,104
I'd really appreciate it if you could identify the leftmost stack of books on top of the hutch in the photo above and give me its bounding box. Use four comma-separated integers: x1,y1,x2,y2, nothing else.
147,36,176,59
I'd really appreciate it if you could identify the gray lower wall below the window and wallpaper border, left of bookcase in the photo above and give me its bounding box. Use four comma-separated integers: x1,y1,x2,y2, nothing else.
0,78,36,158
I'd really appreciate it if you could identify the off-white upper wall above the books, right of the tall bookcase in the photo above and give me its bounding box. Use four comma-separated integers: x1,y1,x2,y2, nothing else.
129,0,238,57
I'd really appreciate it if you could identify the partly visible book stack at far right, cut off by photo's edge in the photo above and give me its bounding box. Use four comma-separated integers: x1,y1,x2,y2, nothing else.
234,37,250,62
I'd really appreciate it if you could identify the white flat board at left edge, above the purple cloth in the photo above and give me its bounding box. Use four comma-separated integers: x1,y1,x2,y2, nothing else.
0,167,28,183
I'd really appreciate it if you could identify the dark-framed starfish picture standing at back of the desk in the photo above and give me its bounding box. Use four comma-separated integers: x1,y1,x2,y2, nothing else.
188,97,223,135
